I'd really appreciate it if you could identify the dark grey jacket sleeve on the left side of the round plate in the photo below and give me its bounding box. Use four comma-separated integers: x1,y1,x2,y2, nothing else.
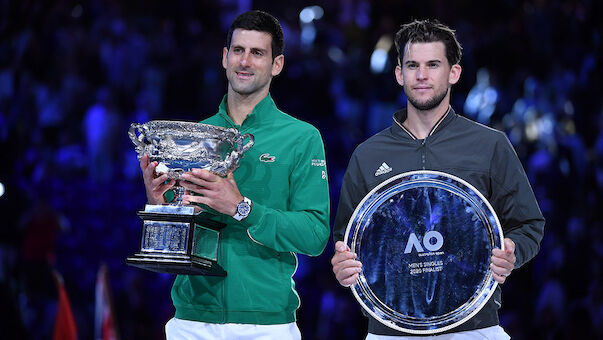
333,152,368,242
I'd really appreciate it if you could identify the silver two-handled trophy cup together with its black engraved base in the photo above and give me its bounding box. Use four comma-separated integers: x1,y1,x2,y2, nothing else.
126,120,254,276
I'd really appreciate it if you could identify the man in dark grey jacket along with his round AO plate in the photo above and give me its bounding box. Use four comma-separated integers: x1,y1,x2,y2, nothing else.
331,20,544,339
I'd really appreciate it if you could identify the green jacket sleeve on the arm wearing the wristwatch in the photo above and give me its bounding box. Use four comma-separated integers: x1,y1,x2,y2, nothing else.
242,129,330,256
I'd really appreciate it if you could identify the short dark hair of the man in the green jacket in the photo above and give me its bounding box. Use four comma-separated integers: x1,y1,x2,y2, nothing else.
226,10,285,60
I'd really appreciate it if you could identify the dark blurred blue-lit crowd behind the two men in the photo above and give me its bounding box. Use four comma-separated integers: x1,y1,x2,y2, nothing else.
0,0,603,339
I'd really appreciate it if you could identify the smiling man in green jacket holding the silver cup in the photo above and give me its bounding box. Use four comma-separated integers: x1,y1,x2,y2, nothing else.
140,11,330,339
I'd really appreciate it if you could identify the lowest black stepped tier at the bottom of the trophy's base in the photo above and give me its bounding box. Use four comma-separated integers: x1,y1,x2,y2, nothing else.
126,253,226,276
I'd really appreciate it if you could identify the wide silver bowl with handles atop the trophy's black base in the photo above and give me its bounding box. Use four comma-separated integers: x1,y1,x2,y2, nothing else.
128,120,254,179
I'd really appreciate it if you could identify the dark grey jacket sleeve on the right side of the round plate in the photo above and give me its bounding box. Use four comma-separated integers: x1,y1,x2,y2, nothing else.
490,135,545,268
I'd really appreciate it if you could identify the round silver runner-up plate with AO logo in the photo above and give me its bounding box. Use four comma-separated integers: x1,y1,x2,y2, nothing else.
344,171,504,334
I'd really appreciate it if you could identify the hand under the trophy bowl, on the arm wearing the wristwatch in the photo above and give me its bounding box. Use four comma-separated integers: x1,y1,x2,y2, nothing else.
180,169,243,216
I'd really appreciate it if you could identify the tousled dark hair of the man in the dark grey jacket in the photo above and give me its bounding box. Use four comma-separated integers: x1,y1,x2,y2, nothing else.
394,19,463,66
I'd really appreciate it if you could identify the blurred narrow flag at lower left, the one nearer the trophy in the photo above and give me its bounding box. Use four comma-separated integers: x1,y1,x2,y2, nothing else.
94,264,119,340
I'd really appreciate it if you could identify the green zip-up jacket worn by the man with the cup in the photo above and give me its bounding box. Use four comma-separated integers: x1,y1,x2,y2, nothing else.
172,95,330,324
